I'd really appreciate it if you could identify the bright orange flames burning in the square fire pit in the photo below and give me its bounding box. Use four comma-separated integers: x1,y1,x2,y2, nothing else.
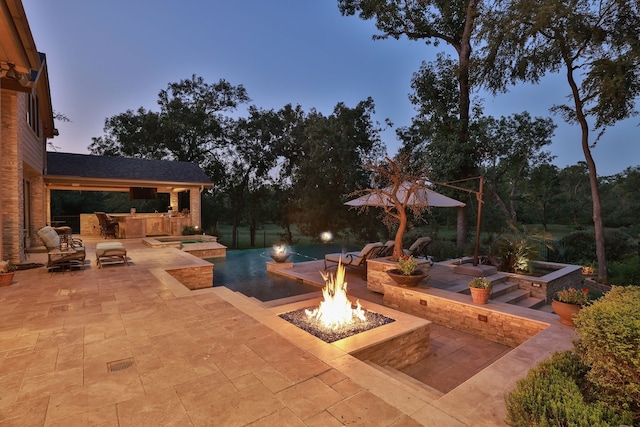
305,262,367,329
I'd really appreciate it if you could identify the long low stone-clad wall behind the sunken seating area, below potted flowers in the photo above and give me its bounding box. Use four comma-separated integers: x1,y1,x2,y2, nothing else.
383,284,548,347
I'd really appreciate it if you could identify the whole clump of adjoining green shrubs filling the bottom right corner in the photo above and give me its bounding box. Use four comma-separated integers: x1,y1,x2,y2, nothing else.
505,286,640,427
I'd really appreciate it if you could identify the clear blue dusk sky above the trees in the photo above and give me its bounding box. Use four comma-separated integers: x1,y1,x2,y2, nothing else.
23,0,640,175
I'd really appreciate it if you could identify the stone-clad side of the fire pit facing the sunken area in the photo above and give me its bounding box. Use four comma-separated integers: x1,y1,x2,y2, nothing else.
351,323,431,370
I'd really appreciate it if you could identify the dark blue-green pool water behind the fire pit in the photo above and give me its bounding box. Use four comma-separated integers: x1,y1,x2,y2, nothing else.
207,243,359,301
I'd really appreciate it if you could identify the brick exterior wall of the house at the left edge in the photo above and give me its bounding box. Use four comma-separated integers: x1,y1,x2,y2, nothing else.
0,89,46,263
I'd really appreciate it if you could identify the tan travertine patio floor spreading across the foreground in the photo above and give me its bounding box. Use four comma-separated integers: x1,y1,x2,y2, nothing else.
0,240,573,426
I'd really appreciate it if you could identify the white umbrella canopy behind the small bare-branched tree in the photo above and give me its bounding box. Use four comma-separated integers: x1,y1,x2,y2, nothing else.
345,182,466,208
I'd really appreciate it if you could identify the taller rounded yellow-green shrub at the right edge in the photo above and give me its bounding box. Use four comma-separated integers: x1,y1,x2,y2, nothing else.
575,286,640,423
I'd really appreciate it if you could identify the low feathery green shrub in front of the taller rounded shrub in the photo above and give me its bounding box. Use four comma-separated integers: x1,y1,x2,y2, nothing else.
505,351,631,427
